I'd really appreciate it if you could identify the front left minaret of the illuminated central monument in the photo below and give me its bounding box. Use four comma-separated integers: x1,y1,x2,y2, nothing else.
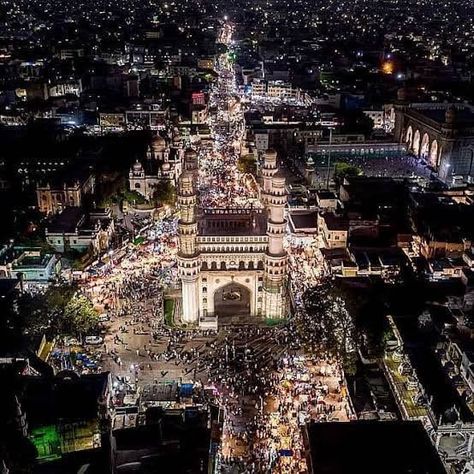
177,170,201,323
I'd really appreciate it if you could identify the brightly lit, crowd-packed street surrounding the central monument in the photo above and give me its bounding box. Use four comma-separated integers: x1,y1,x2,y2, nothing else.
46,21,353,474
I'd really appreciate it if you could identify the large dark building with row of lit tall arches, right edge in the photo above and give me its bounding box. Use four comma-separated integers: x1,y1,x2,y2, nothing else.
394,97,474,185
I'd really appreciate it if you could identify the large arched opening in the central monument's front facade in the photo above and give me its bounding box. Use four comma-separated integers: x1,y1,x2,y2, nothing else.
213,281,252,317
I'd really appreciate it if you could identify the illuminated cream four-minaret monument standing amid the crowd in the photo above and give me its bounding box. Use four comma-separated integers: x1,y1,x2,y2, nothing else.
178,150,287,327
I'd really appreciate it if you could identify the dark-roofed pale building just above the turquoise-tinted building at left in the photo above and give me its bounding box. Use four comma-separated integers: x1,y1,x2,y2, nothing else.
45,207,115,255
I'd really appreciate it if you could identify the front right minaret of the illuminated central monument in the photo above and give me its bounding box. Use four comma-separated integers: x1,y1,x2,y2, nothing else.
264,159,287,318
